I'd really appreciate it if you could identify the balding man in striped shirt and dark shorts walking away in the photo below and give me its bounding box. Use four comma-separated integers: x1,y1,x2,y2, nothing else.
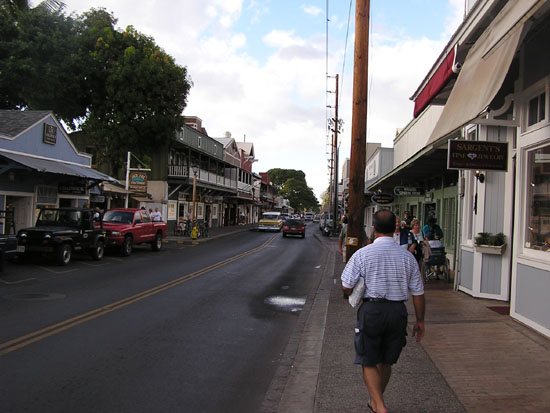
341,210,425,413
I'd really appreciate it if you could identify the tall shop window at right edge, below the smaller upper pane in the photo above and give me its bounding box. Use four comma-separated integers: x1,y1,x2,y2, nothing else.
525,144,550,251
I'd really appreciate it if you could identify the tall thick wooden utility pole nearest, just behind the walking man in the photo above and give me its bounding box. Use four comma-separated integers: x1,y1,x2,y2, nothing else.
346,0,370,259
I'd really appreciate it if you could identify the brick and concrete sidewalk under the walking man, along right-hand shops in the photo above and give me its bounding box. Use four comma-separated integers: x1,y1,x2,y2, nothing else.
278,235,550,413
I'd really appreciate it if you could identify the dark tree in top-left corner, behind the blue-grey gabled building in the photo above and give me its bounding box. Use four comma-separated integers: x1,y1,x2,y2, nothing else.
0,0,86,116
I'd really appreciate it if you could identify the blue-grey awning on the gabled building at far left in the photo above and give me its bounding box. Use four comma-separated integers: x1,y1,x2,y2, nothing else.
0,151,119,183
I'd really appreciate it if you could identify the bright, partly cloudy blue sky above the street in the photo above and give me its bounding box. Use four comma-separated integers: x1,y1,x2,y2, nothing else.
41,0,465,199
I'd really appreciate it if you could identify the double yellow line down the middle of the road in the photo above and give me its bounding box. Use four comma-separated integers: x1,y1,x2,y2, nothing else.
0,237,275,356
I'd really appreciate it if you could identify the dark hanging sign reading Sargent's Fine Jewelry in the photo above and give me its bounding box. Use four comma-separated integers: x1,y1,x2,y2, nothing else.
447,139,508,171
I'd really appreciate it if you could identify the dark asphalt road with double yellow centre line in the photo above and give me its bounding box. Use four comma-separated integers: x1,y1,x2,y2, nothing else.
0,227,325,412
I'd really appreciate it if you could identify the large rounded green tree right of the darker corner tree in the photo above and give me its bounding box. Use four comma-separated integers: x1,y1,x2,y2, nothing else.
75,9,191,174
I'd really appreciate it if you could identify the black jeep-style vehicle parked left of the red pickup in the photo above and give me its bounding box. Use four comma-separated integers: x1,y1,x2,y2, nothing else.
17,208,106,265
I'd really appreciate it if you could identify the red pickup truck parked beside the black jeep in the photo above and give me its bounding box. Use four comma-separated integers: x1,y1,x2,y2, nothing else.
102,208,166,257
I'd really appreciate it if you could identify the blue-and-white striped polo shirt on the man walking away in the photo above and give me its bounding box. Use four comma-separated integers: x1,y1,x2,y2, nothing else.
341,236,424,301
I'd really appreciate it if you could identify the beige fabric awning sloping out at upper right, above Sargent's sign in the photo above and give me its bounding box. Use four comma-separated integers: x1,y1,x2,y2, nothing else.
428,0,543,144
